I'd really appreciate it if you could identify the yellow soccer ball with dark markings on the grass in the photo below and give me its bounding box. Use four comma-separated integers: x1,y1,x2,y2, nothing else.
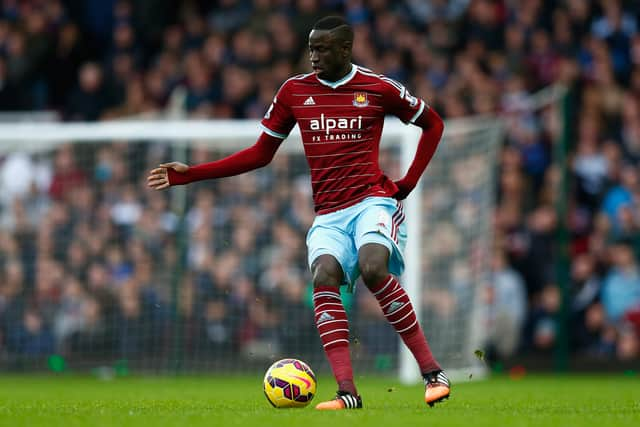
263,359,316,408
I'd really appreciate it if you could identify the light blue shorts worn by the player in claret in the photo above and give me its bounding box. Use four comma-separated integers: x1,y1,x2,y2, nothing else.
307,197,407,285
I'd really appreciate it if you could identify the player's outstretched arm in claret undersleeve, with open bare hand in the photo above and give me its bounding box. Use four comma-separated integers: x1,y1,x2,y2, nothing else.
147,133,282,190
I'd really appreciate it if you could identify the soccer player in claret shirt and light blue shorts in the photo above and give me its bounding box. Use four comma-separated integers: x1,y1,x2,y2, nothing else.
148,16,450,410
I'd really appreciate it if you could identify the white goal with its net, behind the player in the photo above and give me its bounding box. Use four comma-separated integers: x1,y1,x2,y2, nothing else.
0,117,501,381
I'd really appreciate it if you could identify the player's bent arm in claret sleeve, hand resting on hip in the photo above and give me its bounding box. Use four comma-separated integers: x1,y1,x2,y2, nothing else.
393,108,444,200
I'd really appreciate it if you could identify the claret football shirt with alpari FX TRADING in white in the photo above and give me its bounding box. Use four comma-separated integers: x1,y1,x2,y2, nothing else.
262,65,429,214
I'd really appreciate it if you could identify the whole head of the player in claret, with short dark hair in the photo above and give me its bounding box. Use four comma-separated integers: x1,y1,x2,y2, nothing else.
309,16,353,80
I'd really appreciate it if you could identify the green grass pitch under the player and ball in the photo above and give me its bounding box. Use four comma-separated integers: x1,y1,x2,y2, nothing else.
0,374,640,427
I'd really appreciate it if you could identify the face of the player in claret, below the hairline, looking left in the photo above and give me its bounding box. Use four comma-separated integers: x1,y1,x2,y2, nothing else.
309,30,350,81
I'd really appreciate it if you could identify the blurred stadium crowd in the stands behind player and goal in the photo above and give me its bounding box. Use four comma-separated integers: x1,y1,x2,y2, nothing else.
0,0,640,370
